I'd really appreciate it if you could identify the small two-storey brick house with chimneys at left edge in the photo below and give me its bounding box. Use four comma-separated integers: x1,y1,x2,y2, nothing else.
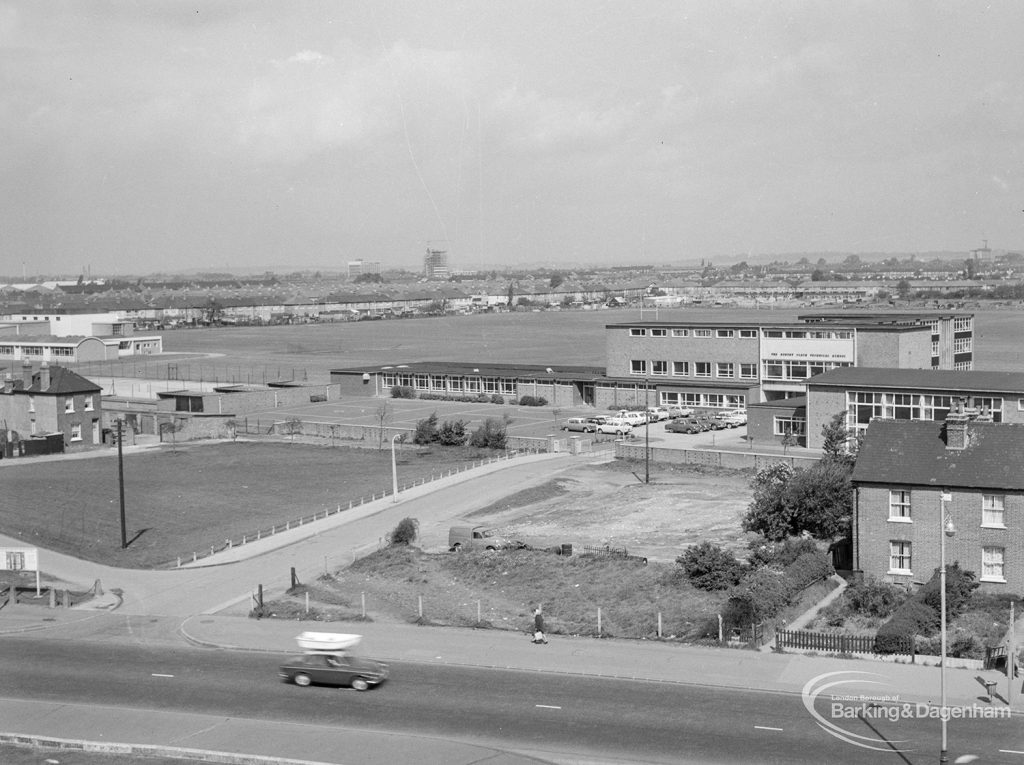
0,362,102,450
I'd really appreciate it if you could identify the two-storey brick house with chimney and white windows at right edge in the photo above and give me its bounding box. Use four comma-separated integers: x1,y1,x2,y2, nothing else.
853,408,1024,594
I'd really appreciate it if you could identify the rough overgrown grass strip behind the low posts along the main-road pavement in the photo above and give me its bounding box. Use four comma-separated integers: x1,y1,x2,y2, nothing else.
267,547,725,641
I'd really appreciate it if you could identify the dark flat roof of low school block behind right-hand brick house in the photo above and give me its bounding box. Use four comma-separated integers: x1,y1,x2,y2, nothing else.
808,367,1024,395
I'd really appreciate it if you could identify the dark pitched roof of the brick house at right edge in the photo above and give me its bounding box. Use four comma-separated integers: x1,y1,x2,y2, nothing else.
853,420,1024,491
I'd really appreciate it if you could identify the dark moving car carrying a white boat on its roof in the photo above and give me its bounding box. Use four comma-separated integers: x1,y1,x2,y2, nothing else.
278,632,390,690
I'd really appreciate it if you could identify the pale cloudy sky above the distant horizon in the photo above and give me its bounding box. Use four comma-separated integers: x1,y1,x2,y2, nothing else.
0,0,1024,277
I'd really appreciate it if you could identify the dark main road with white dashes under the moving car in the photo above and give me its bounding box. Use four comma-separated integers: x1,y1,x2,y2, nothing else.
0,638,1024,765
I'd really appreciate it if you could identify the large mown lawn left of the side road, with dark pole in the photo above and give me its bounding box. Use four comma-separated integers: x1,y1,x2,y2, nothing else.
0,441,499,568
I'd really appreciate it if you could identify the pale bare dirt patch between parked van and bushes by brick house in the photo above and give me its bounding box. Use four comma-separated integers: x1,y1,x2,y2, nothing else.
421,461,751,561
